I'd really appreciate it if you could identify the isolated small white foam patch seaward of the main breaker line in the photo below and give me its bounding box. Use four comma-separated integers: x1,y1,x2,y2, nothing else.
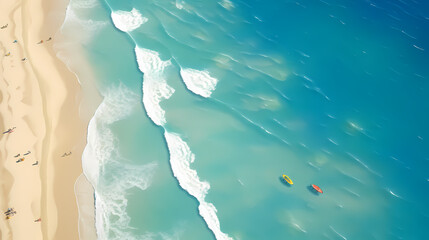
180,68,218,98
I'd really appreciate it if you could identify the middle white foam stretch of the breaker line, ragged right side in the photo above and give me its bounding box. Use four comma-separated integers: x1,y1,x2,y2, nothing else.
135,47,174,126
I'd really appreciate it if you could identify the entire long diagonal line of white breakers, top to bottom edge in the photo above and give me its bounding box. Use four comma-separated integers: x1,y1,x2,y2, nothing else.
106,2,232,240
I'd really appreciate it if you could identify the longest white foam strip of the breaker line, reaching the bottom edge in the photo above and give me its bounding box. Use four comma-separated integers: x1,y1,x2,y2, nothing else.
164,131,232,240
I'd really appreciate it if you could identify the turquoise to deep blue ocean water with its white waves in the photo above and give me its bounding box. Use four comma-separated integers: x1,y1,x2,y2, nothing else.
62,0,429,240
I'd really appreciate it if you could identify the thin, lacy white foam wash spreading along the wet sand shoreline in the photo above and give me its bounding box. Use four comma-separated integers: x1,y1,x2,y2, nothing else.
82,84,157,240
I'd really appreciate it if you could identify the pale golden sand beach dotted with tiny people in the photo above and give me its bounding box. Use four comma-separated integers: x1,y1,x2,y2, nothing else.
0,0,96,240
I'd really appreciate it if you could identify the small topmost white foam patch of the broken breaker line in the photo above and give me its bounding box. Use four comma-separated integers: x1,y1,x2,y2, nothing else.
111,8,148,32
